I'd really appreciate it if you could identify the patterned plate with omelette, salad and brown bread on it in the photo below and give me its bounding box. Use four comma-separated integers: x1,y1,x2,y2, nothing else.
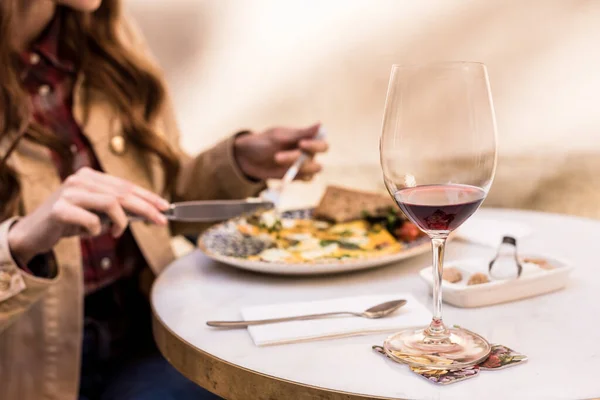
198,186,430,275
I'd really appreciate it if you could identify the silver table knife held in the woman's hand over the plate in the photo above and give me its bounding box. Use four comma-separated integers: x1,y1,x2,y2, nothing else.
98,199,274,224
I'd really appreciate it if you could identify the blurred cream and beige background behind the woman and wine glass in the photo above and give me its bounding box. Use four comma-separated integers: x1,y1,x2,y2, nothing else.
125,0,600,217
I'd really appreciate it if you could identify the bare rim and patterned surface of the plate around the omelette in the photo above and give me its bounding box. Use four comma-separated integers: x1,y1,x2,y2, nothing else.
198,209,431,275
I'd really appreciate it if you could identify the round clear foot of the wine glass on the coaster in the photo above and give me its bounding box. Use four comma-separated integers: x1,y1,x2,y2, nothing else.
383,328,491,369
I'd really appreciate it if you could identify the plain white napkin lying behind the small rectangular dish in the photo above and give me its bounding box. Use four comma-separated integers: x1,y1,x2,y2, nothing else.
456,218,532,247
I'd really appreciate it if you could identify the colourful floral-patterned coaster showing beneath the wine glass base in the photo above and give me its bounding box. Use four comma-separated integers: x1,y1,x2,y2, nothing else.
373,344,527,385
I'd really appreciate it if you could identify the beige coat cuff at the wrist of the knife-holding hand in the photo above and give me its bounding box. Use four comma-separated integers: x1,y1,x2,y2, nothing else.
0,218,27,302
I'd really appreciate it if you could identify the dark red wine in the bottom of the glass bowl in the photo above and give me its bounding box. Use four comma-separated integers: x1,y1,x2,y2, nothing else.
394,184,486,233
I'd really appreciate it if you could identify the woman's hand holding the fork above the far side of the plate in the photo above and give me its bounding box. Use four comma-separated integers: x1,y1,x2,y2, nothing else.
235,124,329,180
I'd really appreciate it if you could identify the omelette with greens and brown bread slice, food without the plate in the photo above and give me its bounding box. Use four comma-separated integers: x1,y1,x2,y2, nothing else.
232,187,421,263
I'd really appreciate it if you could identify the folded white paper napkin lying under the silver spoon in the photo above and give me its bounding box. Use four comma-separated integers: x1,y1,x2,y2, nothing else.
242,293,431,346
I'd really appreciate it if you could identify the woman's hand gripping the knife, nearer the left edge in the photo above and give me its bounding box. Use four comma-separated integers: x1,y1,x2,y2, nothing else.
8,168,169,264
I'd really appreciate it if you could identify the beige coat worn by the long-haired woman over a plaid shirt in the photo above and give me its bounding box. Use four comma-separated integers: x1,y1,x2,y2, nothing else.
0,17,260,400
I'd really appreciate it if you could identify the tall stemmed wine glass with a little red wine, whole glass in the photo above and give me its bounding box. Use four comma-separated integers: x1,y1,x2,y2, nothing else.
380,62,497,369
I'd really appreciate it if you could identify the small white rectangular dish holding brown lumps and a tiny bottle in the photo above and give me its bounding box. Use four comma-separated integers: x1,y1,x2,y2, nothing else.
420,255,573,308
